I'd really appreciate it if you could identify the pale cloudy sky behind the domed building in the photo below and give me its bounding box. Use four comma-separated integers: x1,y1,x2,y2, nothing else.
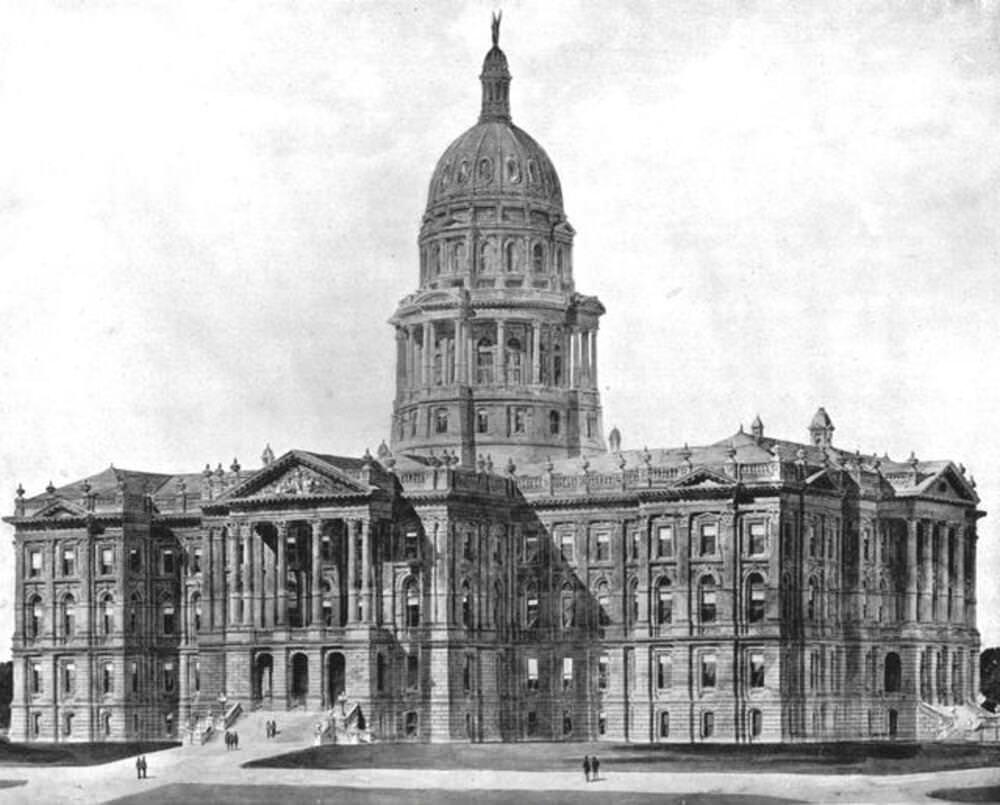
0,0,1000,656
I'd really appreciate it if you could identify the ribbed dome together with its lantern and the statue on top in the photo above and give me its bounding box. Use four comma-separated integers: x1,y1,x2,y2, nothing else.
427,17,563,214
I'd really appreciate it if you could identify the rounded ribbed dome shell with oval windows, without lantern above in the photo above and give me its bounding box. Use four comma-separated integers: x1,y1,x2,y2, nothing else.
427,120,562,212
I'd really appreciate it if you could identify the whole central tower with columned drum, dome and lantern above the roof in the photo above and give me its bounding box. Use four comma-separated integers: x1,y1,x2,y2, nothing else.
391,17,604,466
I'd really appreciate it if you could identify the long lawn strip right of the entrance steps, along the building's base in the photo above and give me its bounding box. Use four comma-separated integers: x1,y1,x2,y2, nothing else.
246,742,1000,775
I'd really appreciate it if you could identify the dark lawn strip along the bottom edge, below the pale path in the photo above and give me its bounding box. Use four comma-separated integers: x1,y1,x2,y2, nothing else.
105,783,797,805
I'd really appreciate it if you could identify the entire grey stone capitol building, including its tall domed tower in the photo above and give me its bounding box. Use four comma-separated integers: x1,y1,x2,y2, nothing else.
5,22,983,742
